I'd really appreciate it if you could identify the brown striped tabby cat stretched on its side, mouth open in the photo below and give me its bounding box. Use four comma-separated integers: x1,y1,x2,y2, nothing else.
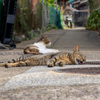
0,45,86,68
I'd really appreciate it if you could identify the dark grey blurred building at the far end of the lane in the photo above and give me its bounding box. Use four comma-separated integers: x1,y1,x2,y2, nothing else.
72,0,89,26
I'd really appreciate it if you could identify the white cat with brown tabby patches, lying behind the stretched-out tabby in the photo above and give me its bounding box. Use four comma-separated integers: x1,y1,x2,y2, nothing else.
24,36,59,55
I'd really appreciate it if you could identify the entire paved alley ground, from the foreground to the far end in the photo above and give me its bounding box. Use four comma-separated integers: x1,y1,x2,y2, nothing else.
0,29,100,100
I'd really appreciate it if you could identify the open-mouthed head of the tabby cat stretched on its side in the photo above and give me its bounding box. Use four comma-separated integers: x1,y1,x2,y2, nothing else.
73,45,86,65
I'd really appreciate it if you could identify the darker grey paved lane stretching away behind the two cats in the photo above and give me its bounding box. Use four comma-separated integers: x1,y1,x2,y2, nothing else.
17,29,100,51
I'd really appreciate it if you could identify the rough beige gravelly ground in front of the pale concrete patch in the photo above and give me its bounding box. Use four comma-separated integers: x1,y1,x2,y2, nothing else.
0,84,100,100
